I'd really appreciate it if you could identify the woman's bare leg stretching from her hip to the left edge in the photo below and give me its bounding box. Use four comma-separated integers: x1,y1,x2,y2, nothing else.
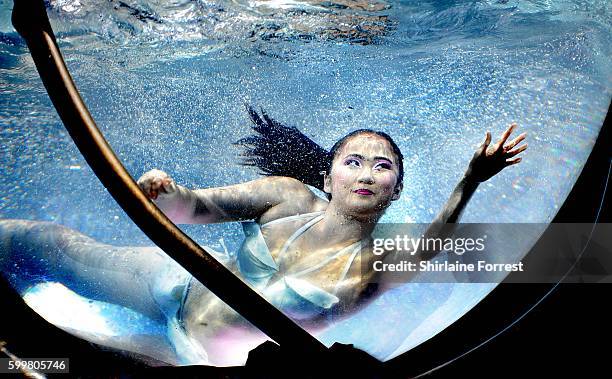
0,220,188,326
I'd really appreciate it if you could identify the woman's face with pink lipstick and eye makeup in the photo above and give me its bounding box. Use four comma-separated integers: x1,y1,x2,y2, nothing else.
324,133,402,216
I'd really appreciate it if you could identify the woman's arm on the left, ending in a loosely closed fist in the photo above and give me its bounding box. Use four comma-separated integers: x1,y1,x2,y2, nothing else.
138,170,315,224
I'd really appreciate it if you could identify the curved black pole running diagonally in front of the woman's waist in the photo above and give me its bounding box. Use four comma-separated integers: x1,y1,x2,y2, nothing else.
12,0,326,360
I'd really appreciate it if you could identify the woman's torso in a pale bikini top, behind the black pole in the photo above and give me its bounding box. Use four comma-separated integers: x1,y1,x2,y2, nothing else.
182,199,371,338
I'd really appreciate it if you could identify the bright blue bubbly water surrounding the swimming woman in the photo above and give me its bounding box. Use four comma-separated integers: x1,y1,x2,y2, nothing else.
0,0,612,368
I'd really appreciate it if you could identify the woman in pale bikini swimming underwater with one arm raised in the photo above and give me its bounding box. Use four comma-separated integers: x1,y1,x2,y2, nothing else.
0,109,527,366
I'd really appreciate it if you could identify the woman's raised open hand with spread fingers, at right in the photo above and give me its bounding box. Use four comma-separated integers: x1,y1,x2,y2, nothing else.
466,124,527,182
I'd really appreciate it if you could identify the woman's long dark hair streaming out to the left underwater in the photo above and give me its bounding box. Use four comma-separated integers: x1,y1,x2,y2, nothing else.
235,106,404,197
